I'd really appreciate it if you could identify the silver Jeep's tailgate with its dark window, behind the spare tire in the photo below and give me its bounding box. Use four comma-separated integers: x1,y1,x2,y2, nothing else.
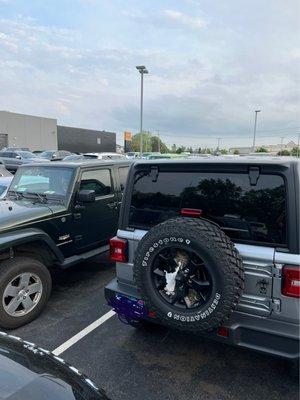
128,164,288,317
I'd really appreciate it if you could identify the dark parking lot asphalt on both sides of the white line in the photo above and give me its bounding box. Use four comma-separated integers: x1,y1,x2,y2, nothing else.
4,255,299,400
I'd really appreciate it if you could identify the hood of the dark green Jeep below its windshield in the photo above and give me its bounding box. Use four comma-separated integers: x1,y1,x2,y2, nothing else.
0,199,52,233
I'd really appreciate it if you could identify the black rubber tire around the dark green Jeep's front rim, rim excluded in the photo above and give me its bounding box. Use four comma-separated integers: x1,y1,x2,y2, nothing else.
0,257,52,329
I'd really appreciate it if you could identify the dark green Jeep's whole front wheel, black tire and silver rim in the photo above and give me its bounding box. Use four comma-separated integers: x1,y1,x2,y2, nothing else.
0,257,52,329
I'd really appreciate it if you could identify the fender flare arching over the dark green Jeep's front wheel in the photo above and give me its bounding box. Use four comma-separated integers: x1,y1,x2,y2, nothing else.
0,228,65,264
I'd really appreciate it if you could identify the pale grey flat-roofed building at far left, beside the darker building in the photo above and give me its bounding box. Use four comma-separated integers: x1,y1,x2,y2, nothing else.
0,111,57,151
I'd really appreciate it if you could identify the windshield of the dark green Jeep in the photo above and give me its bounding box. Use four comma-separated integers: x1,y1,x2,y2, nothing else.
9,167,73,198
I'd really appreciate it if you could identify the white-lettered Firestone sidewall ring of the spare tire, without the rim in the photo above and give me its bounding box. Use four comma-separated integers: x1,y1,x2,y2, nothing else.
134,220,239,330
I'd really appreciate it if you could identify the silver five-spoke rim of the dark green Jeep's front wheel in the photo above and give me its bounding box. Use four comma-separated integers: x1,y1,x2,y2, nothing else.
2,272,43,317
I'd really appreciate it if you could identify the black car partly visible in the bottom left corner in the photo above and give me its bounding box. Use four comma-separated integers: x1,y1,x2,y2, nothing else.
0,332,108,400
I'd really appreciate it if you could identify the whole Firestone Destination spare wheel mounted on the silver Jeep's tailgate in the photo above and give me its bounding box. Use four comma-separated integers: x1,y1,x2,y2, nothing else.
134,217,244,331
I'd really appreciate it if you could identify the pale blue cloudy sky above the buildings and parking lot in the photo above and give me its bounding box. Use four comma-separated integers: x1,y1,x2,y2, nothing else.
0,0,300,147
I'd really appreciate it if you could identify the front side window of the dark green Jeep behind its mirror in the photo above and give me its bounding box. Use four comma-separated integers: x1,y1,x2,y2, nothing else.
80,169,112,197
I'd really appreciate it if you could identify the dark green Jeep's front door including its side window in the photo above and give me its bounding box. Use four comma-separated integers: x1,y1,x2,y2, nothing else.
74,166,118,251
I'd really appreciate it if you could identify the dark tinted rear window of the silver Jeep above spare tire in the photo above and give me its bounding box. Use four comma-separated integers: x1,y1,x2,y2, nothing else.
129,172,287,245
